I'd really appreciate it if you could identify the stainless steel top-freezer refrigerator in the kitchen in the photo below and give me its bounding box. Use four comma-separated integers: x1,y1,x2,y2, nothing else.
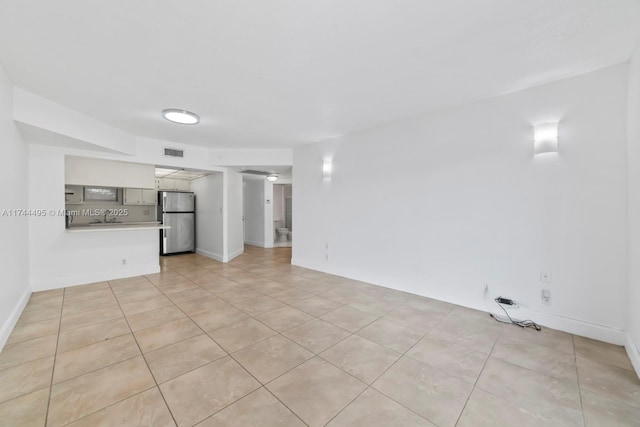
158,191,196,255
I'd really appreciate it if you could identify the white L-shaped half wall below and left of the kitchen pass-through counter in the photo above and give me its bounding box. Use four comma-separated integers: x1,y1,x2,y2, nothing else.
29,144,160,291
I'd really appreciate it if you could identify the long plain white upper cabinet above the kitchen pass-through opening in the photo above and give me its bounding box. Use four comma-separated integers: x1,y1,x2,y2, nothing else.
65,156,155,189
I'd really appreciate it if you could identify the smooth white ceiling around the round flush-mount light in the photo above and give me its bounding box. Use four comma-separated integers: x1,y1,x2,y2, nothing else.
0,0,640,148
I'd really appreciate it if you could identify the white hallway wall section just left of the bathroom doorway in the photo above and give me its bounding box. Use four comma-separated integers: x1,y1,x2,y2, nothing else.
243,177,265,247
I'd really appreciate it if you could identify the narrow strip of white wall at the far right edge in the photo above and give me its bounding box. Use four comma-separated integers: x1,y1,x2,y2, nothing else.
626,46,640,375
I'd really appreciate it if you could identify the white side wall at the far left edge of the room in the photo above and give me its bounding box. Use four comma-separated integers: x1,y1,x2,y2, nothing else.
0,64,31,350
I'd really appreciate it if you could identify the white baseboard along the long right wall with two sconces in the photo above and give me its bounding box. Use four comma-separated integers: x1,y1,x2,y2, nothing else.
291,257,626,345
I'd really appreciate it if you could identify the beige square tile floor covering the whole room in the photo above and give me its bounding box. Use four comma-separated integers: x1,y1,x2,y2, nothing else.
0,246,640,427
